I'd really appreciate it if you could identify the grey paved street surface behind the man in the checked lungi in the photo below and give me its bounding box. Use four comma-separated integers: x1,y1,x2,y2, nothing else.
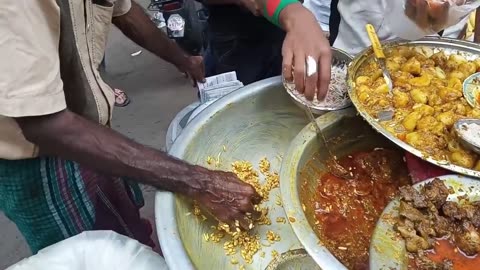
0,0,196,269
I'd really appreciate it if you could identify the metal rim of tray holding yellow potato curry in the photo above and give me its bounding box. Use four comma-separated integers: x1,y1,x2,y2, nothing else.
347,38,480,178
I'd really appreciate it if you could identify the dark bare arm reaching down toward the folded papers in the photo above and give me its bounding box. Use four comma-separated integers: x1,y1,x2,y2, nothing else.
112,1,205,81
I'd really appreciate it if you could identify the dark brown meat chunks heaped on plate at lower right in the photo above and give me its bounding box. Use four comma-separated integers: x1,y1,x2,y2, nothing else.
394,179,480,264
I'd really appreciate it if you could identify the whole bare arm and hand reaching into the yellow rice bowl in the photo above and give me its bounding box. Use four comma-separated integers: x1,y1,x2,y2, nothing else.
16,110,261,229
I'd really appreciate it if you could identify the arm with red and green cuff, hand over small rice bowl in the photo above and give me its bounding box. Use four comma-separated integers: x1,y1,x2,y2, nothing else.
195,0,332,100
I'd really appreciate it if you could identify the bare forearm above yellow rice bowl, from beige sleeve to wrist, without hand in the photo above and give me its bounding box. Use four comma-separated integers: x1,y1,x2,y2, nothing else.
16,110,202,194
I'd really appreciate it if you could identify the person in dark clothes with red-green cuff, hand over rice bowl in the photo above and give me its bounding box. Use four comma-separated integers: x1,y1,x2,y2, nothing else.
202,0,331,99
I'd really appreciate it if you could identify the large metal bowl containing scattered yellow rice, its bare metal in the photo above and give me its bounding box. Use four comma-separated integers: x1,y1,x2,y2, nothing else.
155,77,324,270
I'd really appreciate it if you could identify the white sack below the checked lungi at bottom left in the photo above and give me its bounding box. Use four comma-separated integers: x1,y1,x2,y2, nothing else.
7,231,168,270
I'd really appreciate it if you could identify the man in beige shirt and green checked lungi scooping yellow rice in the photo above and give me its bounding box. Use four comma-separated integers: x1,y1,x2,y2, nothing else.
0,0,260,253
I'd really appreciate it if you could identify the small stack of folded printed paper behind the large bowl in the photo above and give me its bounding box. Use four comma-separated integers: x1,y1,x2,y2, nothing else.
198,72,243,104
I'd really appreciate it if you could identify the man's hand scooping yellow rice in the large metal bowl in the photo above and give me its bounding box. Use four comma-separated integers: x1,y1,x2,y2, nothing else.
193,170,262,230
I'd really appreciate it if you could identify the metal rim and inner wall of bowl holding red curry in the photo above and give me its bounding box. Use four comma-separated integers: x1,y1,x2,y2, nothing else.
280,108,404,270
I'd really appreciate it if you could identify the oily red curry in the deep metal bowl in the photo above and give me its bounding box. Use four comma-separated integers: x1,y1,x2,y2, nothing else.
304,149,411,270
